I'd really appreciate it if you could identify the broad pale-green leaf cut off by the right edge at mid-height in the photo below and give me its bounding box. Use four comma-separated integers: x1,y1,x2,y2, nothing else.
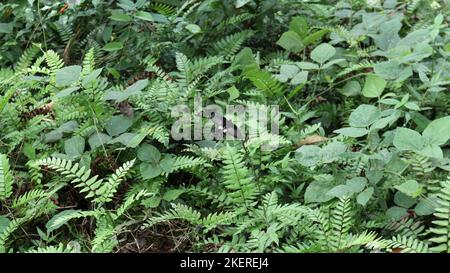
422,116,450,146
